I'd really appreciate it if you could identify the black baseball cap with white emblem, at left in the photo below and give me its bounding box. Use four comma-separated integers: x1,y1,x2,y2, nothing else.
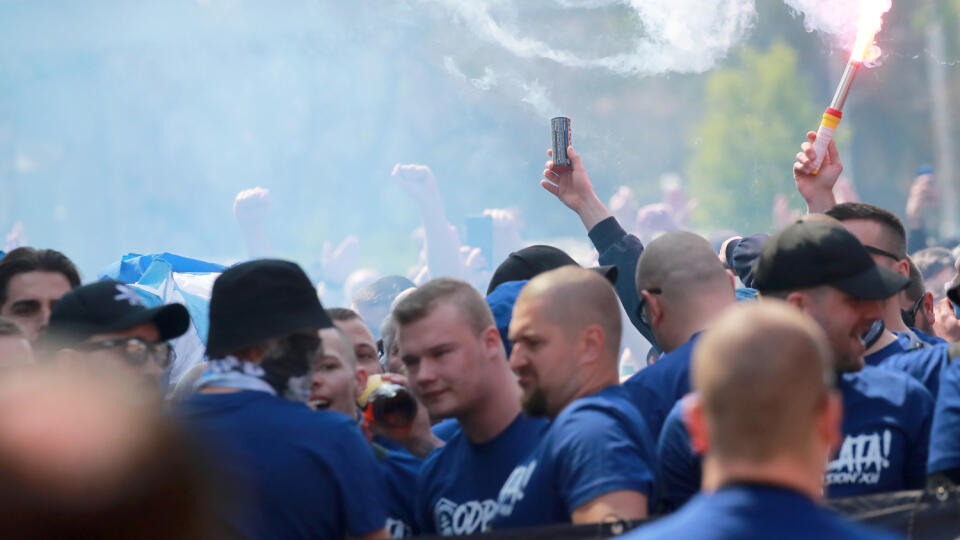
44,280,190,347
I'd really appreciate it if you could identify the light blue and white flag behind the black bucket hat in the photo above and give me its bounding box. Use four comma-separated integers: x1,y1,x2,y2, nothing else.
97,253,227,389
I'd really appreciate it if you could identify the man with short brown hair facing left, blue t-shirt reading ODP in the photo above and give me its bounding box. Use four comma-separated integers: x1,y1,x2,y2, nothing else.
393,279,546,536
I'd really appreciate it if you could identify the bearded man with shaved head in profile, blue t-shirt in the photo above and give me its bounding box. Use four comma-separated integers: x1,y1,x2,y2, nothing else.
494,267,656,529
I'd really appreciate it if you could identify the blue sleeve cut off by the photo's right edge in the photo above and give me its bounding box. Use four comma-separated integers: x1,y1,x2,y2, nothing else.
927,363,960,474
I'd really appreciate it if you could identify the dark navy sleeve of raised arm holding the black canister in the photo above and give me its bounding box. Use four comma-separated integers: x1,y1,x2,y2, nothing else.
587,217,660,351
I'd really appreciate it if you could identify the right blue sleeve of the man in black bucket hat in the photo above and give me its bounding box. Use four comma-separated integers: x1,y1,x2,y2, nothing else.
323,420,387,536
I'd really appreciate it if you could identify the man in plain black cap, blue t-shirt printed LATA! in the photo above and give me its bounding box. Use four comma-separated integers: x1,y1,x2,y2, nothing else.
659,222,933,510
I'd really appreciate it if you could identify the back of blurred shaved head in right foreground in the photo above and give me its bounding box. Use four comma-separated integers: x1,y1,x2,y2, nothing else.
692,300,833,463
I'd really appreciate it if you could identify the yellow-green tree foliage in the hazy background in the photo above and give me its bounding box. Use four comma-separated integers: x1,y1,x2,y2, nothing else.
688,42,820,233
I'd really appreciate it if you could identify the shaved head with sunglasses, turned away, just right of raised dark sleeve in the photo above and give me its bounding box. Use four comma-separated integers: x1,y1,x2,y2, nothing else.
636,231,732,305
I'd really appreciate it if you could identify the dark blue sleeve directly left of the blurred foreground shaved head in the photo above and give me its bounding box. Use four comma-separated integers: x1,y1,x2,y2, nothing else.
657,402,702,513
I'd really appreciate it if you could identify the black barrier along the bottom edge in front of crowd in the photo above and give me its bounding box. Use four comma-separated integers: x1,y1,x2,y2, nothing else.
423,488,960,540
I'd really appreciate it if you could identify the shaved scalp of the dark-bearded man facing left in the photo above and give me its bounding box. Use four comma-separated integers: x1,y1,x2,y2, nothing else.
517,266,622,361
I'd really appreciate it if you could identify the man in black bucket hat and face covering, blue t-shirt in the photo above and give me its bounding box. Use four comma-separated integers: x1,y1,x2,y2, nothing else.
175,259,388,540
